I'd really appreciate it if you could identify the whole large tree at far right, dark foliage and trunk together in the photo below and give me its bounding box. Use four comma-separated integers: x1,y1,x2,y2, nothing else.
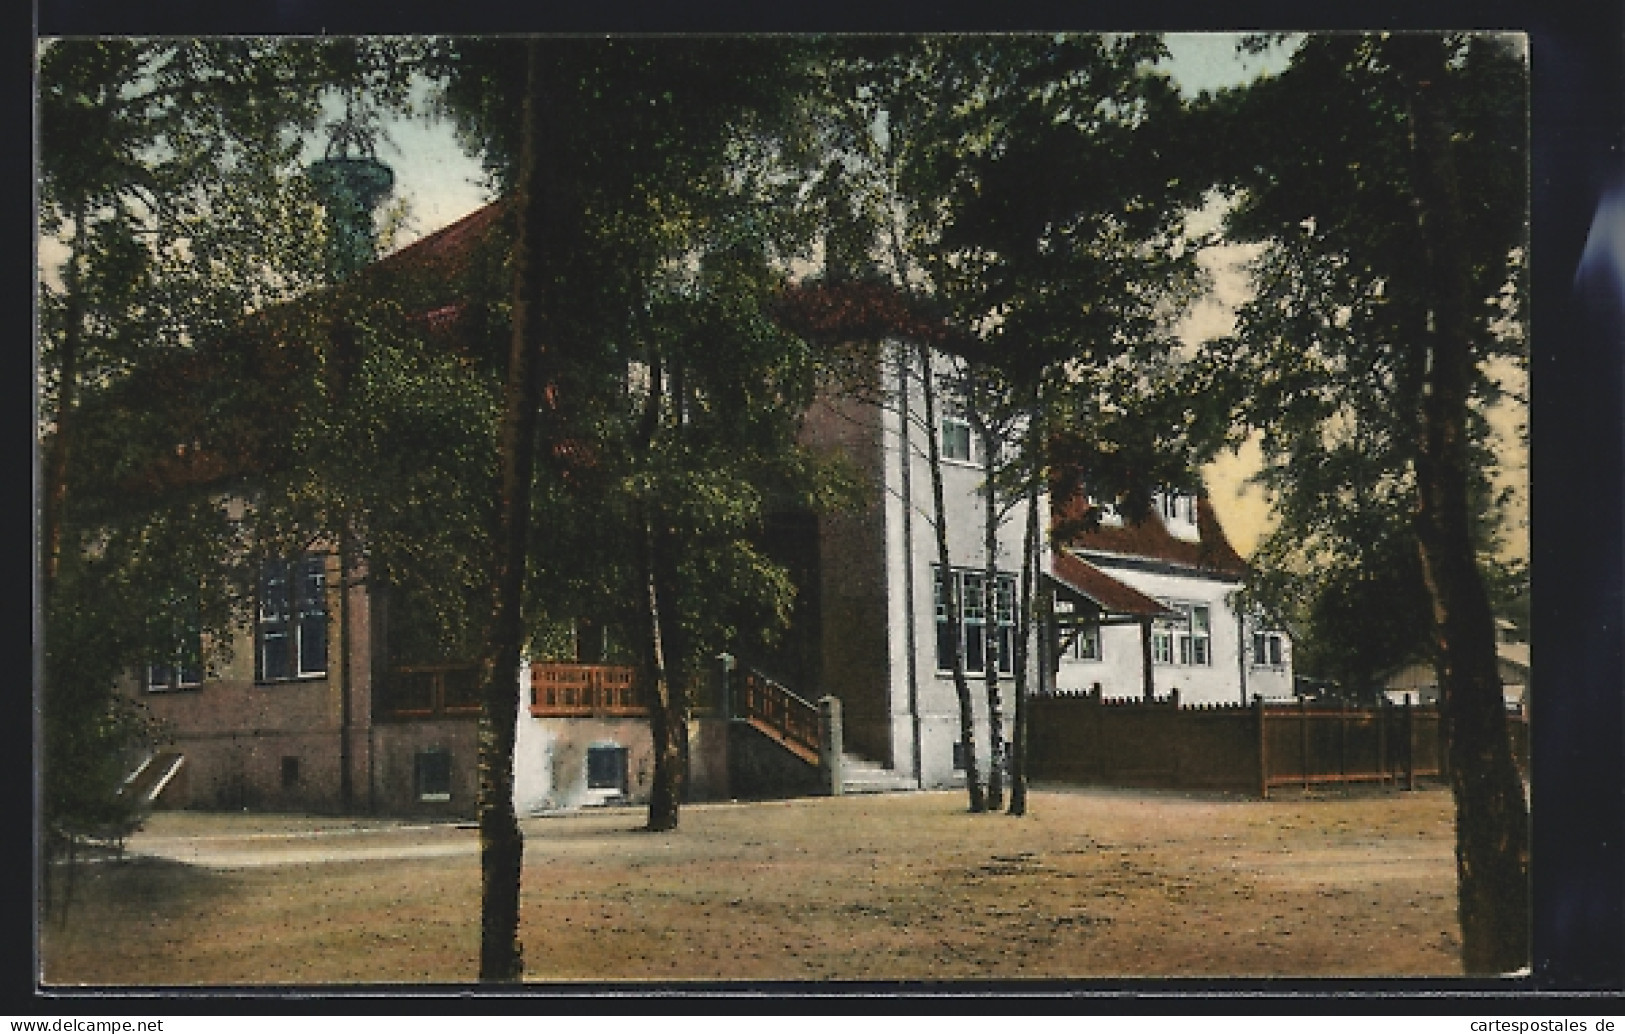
1216,34,1529,972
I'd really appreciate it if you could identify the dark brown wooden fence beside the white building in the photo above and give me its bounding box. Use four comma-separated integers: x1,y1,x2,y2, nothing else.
1027,691,1529,797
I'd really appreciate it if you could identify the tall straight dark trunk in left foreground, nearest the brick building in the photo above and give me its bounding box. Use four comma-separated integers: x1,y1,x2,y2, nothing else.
479,41,561,982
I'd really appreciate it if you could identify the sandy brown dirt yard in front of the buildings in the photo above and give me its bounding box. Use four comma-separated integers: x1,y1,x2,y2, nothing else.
41,789,1461,985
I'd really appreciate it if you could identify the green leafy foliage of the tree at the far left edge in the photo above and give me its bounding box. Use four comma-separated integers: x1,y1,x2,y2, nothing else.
37,39,419,824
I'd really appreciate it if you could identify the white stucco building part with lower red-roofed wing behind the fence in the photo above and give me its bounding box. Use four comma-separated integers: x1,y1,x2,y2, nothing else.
796,346,1292,787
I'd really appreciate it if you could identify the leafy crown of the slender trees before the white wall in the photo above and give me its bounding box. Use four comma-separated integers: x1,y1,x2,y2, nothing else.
819,36,1206,806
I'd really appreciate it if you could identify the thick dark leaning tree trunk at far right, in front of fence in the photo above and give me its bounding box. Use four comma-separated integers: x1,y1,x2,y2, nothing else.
1396,34,1529,974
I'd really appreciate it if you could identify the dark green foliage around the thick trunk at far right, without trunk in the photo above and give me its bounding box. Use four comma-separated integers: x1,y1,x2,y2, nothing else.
1207,36,1528,682
